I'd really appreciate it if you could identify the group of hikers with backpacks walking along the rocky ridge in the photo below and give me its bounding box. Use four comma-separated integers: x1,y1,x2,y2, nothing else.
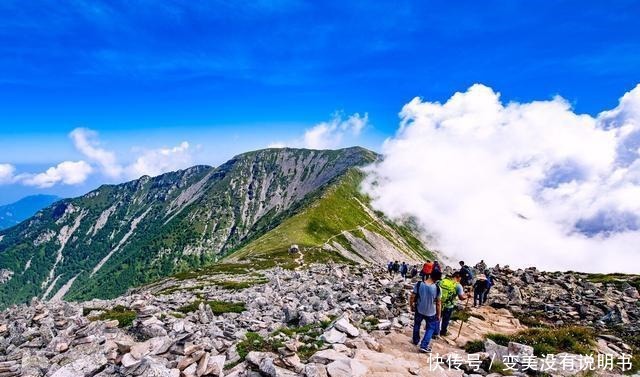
387,260,494,353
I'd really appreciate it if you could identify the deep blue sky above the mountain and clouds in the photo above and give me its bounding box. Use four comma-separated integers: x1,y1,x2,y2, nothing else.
0,0,640,204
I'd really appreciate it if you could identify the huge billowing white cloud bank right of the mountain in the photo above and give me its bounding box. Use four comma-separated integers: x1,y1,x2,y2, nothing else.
364,85,640,273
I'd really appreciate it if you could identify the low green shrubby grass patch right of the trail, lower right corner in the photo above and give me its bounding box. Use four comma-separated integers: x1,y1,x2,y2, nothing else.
487,326,595,356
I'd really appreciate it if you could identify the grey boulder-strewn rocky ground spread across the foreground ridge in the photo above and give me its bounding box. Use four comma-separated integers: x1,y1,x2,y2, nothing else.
0,262,640,377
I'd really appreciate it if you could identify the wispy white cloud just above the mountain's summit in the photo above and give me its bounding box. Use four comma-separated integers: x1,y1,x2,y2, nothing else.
268,113,369,149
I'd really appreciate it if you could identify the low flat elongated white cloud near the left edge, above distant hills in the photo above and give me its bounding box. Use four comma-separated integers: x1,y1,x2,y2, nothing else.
18,161,93,188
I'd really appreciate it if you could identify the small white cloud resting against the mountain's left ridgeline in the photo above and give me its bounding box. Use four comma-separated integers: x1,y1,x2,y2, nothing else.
126,141,193,177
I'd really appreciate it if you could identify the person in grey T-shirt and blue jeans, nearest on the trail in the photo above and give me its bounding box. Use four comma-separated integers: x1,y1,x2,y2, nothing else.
409,272,442,353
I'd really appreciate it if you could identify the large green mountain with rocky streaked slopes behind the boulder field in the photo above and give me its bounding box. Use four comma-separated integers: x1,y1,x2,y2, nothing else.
0,148,436,307
